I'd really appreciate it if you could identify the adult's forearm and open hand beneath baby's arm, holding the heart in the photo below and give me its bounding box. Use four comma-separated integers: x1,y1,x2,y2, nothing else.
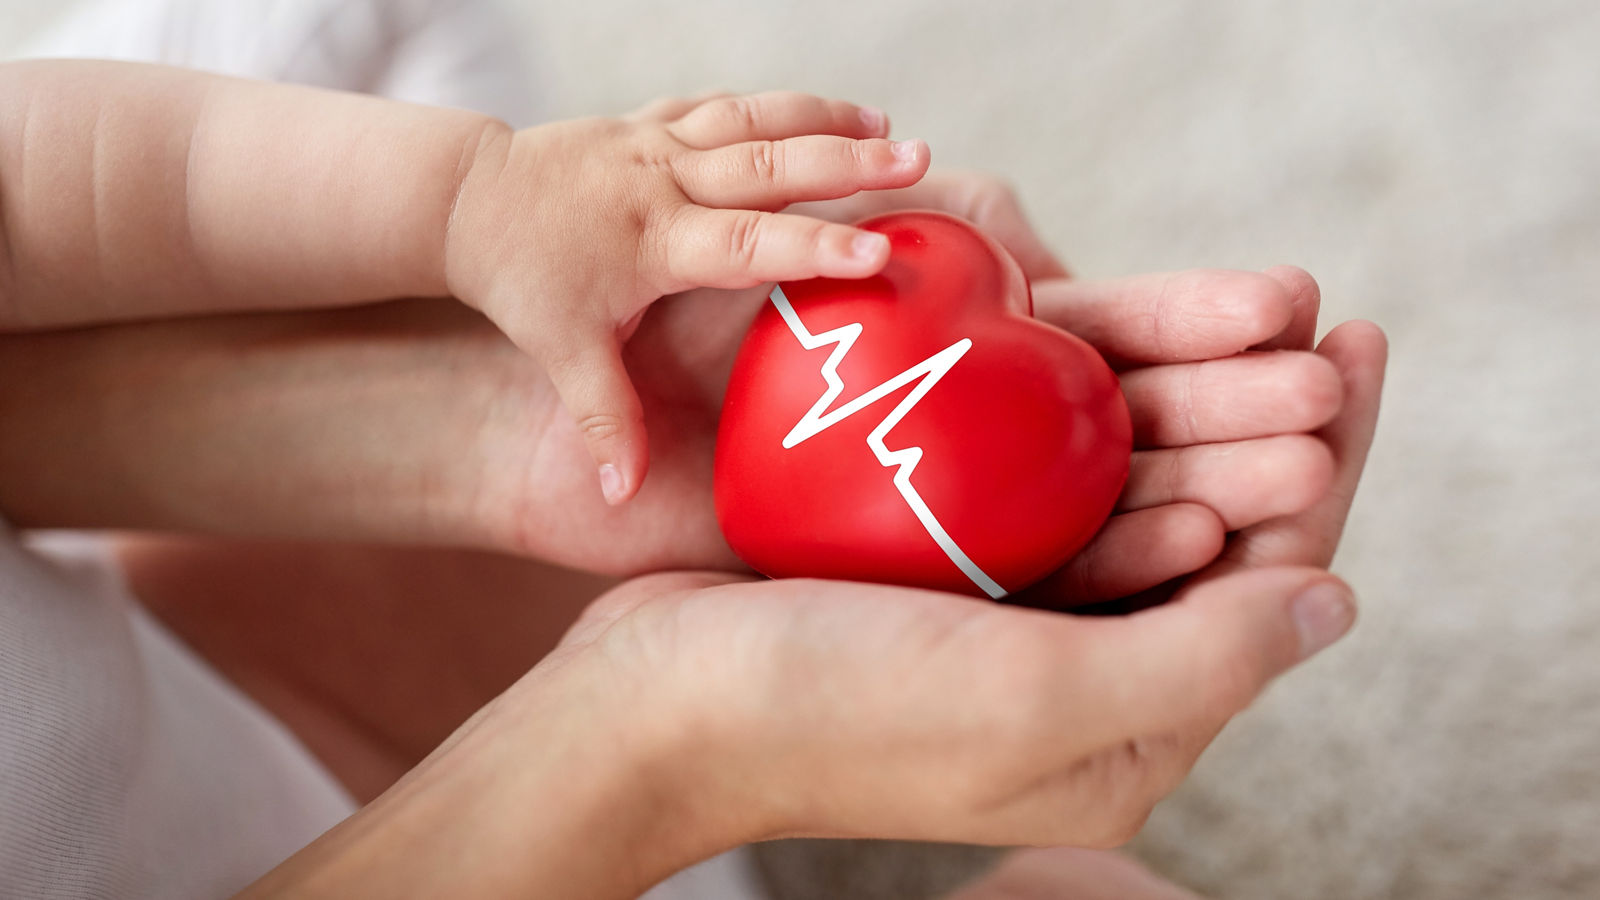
0,265,1339,596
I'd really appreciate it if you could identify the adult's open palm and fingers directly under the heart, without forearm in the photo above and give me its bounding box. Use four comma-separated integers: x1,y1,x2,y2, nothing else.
462,259,1363,605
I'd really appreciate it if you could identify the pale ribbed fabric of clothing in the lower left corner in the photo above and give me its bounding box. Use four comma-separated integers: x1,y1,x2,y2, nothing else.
0,533,354,898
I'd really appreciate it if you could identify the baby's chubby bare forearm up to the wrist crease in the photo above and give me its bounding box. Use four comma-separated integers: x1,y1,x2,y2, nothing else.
0,61,509,330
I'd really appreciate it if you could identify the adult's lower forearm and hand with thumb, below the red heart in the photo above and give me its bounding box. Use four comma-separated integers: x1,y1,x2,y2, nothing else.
236,554,1354,898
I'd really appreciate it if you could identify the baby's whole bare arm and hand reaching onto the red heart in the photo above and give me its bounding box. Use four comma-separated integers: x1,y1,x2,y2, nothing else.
0,62,928,501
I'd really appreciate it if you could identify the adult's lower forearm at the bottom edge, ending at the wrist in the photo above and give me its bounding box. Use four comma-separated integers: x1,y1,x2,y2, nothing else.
242,652,726,900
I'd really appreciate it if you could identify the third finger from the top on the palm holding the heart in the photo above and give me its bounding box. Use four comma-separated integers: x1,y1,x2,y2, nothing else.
1117,434,1334,532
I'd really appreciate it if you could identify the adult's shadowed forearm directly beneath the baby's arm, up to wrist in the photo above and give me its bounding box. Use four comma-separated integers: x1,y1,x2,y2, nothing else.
0,303,505,546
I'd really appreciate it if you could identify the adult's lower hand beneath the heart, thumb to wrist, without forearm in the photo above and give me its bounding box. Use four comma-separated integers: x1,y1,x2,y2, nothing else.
512,569,1354,876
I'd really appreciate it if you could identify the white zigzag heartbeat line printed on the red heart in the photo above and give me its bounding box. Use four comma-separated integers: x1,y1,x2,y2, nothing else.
771,287,1006,601
